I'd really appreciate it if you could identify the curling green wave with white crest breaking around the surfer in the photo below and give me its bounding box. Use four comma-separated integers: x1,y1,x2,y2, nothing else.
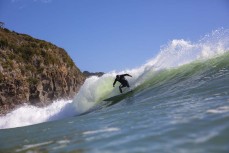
73,29,229,114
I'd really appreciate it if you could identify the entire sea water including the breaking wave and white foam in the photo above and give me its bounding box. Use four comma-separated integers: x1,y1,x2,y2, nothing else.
0,29,229,153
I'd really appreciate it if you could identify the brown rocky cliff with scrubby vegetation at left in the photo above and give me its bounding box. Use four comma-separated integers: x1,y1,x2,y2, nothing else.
0,28,85,114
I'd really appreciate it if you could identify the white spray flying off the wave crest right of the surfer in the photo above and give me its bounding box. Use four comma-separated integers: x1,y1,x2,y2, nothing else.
145,29,229,70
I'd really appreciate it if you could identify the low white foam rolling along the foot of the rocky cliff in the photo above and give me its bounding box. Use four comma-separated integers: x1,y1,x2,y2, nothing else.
0,100,72,129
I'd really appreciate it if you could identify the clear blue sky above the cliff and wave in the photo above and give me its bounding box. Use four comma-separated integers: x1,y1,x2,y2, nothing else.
0,0,229,72
